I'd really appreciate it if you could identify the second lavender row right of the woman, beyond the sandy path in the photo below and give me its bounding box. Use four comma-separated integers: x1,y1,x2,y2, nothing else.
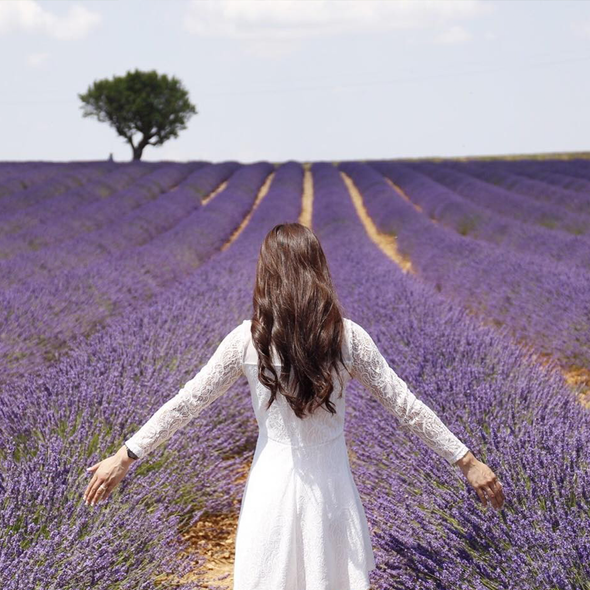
339,163,590,374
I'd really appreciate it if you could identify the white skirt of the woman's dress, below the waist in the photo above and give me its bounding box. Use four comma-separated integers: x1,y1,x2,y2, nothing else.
234,432,375,590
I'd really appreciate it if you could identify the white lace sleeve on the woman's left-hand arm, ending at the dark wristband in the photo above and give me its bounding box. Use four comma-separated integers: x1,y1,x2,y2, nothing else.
125,322,246,458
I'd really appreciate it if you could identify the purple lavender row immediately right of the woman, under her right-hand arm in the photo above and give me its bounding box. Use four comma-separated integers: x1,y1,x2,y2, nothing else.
312,164,590,590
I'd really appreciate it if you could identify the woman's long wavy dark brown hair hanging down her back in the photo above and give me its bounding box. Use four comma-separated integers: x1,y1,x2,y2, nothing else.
251,223,346,418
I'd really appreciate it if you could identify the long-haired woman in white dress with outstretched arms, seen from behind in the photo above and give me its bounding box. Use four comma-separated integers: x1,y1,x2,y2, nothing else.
84,223,504,590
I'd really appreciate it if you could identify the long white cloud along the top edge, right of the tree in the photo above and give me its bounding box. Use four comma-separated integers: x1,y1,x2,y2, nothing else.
183,0,494,41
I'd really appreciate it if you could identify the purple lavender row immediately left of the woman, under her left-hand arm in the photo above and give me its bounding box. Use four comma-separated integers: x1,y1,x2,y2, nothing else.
0,162,303,590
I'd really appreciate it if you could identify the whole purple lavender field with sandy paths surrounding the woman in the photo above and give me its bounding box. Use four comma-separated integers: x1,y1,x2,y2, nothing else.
0,159,590,590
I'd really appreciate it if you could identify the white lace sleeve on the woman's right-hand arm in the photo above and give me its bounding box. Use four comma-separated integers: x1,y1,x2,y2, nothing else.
349,320,469,465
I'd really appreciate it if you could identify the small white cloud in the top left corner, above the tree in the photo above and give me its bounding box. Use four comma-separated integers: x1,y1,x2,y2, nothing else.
0,0,102,40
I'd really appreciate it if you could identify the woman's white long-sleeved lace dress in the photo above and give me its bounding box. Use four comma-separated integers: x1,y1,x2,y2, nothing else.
125,318,468,590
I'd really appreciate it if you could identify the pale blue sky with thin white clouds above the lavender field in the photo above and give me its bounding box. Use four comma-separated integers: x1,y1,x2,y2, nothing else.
0,0,590,162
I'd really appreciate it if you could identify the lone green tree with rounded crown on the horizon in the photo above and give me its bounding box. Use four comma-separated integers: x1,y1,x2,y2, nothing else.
78,70,197,160
